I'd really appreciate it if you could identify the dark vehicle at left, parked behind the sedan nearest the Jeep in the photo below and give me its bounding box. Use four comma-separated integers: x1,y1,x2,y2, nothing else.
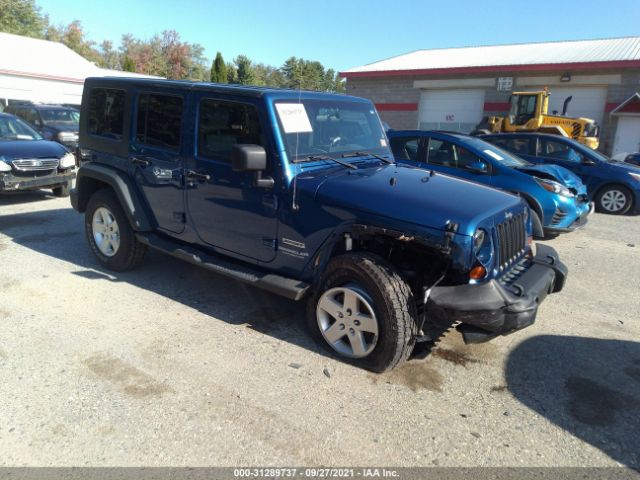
5,103,80,151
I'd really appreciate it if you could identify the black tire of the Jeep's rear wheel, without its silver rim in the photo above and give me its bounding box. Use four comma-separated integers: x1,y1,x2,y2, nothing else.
84,188,147,272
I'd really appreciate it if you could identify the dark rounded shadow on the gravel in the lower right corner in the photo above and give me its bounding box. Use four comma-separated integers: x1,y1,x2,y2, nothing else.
506,335,640,470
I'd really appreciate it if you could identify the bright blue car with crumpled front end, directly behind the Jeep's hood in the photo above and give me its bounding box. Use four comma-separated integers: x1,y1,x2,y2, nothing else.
387,130,592,237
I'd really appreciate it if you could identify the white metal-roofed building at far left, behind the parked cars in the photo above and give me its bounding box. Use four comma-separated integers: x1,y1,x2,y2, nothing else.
0,32,158,109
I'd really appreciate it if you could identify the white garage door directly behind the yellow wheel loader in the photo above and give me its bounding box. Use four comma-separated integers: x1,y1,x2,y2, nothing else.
526,87,607,125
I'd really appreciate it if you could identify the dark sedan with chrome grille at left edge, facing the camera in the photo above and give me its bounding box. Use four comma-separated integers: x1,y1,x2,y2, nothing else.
0,113,76,197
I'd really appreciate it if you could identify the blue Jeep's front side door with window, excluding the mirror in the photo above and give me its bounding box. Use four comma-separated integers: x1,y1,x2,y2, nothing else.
186,94,278,262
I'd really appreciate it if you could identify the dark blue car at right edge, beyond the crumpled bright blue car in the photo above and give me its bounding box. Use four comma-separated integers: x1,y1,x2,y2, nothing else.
481,133,640,215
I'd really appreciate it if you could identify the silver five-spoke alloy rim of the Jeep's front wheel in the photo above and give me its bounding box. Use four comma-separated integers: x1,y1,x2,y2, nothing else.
316,285,378,358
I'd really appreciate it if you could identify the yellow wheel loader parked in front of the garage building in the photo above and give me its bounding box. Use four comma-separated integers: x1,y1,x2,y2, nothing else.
473,89,600,150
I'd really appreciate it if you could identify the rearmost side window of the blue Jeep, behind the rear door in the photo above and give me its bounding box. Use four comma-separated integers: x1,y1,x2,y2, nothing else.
88,88,125,140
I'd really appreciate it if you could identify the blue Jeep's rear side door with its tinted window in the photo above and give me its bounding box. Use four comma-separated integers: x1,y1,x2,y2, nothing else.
129,91,185,233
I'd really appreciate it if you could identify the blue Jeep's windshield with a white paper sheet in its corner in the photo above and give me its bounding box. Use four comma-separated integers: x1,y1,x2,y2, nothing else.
274,98,391,162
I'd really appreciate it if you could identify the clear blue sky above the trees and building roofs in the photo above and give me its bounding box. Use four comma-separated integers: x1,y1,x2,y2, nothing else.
36,0,640,71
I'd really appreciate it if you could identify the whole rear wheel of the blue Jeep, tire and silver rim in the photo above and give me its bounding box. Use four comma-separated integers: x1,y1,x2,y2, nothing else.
85,189,147,271
